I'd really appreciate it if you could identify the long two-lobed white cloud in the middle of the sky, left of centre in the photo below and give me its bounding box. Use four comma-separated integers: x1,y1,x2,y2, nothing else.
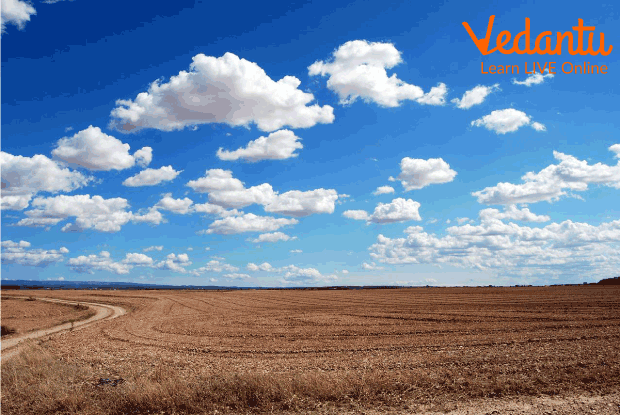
187,169,338,217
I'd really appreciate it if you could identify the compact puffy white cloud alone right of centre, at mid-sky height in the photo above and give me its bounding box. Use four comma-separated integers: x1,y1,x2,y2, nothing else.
389,157,456,191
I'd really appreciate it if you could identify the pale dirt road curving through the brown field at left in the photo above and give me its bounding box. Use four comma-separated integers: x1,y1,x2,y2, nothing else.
0,297,126,360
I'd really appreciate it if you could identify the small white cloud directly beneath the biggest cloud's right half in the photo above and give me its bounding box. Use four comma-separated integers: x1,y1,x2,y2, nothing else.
217,130,304,162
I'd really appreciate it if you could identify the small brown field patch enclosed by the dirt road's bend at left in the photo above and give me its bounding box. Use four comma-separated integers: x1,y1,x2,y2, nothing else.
0,294,93,339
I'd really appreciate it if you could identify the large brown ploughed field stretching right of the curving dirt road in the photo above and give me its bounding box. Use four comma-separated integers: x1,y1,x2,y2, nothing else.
2,286,620,414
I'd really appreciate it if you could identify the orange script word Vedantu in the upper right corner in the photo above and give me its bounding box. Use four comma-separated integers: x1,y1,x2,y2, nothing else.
463,15,613,56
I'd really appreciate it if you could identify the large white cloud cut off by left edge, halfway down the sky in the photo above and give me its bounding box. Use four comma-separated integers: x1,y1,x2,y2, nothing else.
0,151,92,210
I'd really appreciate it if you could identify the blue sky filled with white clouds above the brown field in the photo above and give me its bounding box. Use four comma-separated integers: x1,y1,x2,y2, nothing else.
2,0,620,286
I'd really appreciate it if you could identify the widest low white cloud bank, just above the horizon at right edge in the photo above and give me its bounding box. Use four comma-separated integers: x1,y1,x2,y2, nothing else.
370,215,620,278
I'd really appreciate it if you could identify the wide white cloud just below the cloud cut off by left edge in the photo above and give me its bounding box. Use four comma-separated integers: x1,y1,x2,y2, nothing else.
17,195,133,232
